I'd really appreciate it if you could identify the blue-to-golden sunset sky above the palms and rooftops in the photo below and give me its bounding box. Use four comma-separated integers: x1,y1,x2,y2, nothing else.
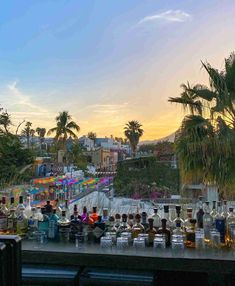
0,0,235,140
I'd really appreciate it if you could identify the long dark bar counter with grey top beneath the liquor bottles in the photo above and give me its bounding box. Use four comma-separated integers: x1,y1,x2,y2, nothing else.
22,241,235,286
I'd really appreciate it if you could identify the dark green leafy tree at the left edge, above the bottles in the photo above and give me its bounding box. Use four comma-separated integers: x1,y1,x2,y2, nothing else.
0,133,33,185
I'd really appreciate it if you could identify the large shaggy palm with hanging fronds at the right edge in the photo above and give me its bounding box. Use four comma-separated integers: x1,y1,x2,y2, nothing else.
169,53,235,194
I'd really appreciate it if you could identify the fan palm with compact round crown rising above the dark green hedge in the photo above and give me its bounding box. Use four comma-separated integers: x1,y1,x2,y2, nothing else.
124,120,144,157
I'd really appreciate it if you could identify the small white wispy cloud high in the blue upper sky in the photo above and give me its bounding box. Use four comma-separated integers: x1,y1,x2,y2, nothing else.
137,10,192,25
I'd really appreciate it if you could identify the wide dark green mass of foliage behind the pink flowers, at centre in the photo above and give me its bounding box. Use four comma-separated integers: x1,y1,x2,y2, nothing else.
114,157,179,199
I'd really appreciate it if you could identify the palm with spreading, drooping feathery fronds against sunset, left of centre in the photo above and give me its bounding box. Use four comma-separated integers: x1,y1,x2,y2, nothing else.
47,111,80,149
